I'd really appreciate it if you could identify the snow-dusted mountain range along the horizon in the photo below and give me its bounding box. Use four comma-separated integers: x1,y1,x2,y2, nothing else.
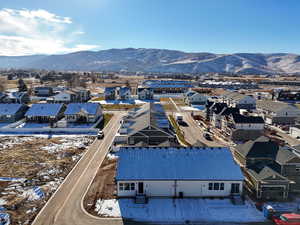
0,48,300,74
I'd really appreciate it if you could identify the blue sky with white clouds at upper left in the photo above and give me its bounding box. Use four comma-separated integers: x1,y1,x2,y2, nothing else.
0,0,300,55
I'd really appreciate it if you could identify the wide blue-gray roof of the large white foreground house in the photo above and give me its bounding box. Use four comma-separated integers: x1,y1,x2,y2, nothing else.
116,147,244,180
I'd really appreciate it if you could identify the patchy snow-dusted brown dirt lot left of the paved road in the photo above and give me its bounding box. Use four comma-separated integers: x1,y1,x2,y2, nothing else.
0,137,93,225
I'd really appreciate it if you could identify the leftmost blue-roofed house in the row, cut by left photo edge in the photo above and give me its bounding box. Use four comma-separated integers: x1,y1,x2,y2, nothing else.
0,103,28,123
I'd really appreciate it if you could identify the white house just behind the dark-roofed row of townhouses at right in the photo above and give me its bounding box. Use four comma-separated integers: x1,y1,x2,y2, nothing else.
223,92,256,110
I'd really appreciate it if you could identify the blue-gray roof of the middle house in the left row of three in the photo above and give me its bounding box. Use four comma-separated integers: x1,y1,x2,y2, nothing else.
25,103,63,116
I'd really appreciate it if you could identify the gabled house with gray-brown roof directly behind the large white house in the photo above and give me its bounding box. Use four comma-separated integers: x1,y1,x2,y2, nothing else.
115,103,177,146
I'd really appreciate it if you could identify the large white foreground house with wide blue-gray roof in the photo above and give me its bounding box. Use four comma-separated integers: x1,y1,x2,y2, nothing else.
116,147,244,197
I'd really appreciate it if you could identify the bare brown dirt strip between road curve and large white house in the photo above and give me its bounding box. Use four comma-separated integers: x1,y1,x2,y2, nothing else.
84,154,117,216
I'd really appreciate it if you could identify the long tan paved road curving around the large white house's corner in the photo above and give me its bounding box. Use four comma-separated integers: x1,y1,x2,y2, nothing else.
32,113,123,225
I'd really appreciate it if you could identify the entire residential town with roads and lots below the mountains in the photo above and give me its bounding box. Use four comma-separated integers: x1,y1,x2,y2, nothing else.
0,69,300,225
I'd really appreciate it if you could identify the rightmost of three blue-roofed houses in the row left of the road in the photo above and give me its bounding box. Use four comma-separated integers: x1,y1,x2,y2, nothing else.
64,103,103,123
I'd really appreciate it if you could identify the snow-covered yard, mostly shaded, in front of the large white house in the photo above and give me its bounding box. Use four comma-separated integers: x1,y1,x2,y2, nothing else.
95,199,265,223
